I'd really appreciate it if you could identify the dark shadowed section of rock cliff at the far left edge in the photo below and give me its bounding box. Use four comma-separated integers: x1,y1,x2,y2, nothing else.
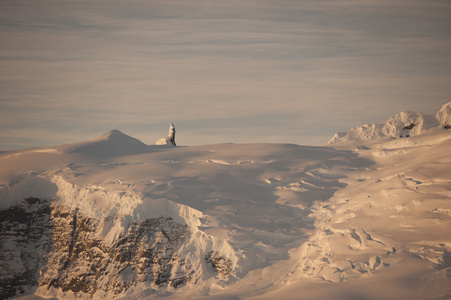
0,198,53,299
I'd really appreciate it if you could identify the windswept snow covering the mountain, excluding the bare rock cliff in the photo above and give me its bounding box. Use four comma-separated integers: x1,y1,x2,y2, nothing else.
0,130,451,299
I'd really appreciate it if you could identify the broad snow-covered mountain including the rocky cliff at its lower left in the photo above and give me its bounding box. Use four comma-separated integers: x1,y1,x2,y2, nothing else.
0,113,451,299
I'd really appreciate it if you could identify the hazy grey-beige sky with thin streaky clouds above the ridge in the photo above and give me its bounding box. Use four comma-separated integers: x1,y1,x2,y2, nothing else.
0,0,451,150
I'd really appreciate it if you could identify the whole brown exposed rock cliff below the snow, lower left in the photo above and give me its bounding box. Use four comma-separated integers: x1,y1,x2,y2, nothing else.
0,198,192,299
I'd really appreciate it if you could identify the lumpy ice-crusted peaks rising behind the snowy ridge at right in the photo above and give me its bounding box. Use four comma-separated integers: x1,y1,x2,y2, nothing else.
329,102,451,144
